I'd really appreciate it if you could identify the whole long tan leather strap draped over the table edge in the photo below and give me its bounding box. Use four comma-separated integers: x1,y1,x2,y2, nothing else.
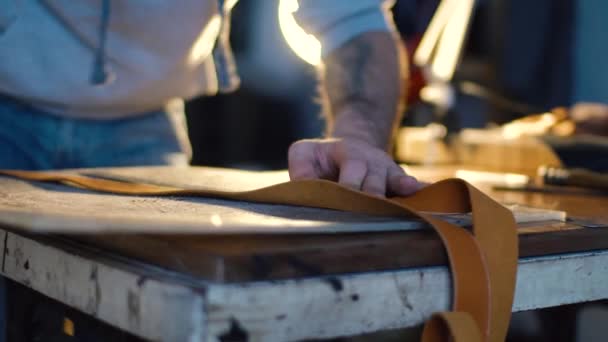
0,170,518,342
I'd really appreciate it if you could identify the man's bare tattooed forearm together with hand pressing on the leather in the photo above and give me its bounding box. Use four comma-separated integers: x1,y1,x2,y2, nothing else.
289,32,421,197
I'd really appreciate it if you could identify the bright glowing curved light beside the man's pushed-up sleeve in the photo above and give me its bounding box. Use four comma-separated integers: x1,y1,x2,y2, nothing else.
279,0,321,65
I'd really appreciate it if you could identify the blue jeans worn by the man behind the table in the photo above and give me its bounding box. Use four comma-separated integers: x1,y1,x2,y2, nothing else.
0,95,190,170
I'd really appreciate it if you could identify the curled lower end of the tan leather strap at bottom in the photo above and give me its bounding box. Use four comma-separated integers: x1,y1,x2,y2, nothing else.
422,311,482,342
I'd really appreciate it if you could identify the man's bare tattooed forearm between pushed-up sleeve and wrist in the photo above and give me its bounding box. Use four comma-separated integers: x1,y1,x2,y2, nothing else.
320,32,407,148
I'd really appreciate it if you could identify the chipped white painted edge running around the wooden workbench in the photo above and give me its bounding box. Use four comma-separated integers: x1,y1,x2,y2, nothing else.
0,230,608,342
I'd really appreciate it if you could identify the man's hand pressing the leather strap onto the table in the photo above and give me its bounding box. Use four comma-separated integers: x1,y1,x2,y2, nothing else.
289,138,421,197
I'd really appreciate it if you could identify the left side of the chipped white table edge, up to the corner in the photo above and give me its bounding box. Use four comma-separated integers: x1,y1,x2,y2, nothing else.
0,230,205,342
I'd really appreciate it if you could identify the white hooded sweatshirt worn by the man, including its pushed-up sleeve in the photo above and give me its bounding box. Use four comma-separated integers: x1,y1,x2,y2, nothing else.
0,0,392,119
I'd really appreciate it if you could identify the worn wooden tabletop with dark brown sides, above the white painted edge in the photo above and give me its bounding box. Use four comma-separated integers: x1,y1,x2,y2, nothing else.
0,167,608,282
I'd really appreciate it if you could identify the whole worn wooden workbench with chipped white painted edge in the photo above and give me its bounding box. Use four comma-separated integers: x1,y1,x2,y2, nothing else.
0,168,608,341
